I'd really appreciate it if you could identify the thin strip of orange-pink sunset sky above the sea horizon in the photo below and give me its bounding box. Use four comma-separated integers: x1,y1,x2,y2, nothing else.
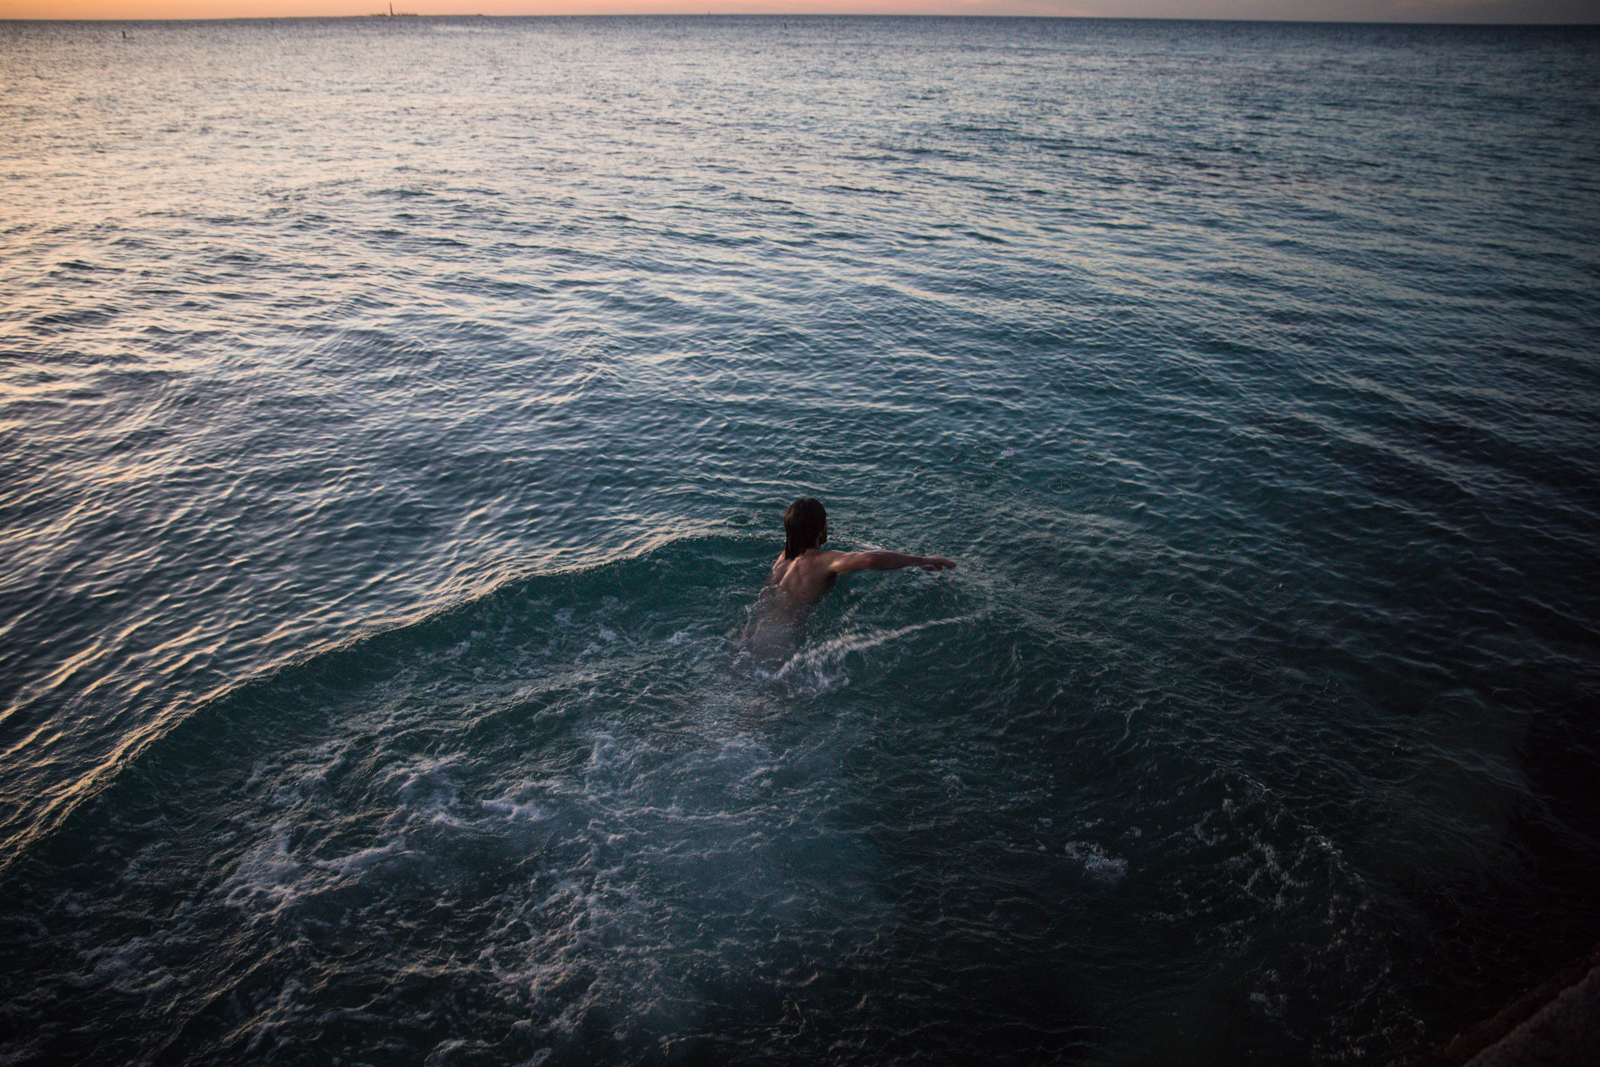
0,0,1600,24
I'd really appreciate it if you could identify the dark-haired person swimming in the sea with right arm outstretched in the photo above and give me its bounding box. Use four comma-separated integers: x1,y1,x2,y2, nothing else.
744,496,955,661
